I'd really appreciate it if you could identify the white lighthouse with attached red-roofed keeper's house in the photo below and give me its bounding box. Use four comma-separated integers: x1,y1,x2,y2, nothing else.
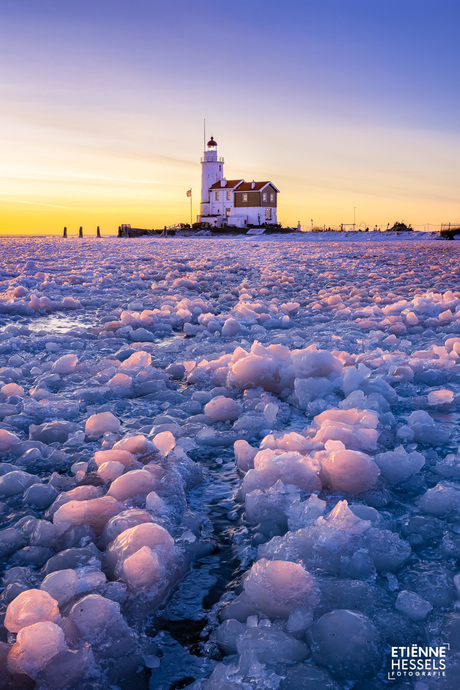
198,137,279,228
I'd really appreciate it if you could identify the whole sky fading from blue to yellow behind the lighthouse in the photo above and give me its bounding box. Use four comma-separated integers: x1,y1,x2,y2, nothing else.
0,0,460,235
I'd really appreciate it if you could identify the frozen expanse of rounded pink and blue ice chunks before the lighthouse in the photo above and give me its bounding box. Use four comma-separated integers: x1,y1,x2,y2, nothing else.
0,234,460,690
